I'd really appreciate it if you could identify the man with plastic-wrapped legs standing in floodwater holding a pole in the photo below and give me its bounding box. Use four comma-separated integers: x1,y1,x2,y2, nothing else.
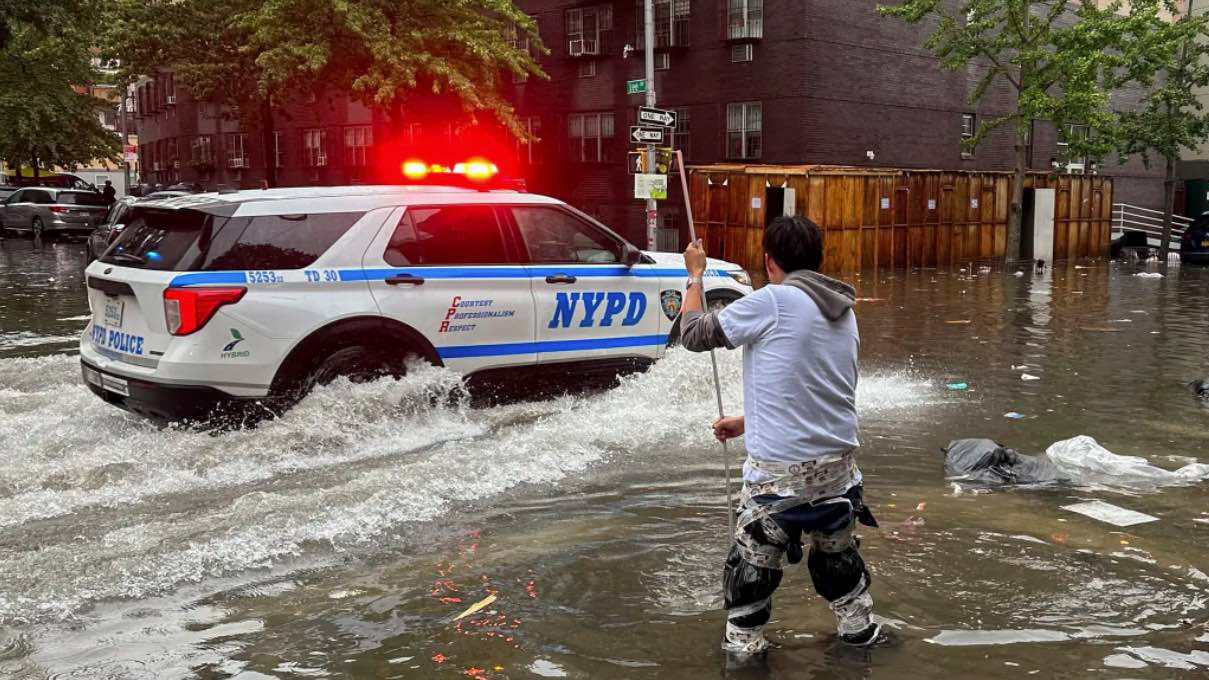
681,217,880,655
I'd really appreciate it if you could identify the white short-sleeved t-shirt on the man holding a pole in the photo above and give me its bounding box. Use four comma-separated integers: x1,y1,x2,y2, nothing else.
718,284,861,483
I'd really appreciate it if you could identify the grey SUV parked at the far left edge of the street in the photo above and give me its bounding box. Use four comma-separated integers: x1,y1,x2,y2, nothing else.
0,186,109,236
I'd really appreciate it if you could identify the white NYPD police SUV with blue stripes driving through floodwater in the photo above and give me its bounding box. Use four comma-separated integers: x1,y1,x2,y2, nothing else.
80,170,751,420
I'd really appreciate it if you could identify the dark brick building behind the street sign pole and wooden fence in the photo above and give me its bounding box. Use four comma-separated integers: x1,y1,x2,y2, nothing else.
516,0,1162,238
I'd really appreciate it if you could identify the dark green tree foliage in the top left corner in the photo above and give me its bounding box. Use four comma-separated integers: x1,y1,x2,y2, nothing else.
0,0,121,177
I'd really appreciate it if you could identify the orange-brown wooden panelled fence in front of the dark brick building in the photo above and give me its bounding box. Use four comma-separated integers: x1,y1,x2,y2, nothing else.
689,165,1112,272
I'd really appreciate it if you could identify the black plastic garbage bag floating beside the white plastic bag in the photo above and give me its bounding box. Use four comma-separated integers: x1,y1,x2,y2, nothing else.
941,439,1070,484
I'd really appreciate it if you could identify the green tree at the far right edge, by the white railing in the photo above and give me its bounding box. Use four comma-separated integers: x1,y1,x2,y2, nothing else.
1110,0,1209,261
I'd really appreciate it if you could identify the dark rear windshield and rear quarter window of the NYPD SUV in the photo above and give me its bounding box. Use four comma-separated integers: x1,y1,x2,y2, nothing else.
102,207,365,271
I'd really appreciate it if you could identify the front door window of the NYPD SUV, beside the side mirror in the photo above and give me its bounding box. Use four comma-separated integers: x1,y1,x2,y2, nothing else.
513,206,621,264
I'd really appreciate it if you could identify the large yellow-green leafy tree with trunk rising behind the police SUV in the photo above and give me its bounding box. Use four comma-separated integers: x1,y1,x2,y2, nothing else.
108,0,543,185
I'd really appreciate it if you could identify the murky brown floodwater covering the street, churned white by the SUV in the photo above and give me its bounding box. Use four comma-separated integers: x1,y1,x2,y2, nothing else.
0,238,1209,679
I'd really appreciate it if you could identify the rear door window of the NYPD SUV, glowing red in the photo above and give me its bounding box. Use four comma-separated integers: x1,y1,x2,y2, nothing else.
382,206,509,266
